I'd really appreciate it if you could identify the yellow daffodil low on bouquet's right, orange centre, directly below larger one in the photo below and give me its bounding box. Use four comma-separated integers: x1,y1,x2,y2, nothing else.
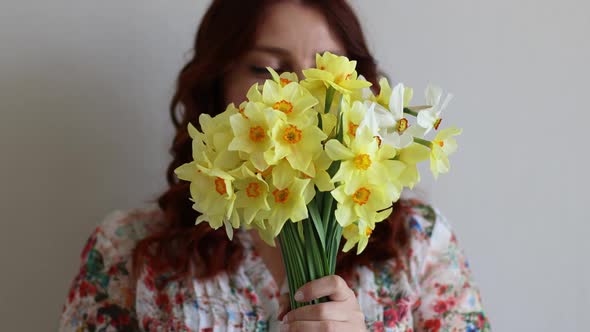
332,184,399,227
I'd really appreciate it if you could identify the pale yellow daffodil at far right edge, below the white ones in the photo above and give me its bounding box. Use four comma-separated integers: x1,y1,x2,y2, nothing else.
430,127,462,179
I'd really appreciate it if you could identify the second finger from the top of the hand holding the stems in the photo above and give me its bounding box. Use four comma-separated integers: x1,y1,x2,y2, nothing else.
283,302,365,322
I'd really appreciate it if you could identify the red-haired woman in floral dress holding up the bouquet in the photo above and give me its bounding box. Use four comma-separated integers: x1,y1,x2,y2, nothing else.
61,0,489,331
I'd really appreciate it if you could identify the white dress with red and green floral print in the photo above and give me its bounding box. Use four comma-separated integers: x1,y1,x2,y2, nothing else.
59,201,490,332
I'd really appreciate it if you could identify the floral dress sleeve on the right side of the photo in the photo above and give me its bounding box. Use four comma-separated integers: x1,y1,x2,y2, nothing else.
414,212,490,332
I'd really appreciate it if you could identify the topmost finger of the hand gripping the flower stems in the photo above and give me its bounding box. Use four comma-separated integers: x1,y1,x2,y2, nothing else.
295,275,354,302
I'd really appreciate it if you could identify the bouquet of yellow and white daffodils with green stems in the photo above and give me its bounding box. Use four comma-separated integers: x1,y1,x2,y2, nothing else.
175,52,461,309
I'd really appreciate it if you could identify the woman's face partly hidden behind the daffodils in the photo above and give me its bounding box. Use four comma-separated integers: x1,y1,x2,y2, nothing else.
224,2,345,105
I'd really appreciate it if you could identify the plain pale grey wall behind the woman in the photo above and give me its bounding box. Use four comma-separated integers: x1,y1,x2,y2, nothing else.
0,0,590,331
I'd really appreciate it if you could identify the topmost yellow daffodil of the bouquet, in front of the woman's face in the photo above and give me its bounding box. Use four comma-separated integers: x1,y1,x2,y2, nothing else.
303,52,371,94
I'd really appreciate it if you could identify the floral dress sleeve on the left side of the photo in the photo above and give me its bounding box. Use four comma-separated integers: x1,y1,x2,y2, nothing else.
59,212,139,332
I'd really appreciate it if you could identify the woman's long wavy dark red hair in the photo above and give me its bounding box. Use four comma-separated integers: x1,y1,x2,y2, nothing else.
133,0,409,286
